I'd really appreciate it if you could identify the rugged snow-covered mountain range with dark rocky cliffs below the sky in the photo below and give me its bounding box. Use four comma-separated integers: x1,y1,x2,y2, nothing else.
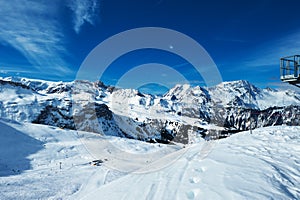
0,78,300,143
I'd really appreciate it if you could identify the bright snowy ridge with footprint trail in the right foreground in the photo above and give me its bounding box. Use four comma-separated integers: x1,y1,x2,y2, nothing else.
78,127,300,199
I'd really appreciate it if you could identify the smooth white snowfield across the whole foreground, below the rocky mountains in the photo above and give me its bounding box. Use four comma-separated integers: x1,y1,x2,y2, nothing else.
0,120,300,200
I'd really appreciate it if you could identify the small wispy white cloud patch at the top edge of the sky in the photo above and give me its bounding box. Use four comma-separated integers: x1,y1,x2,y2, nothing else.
69,0,100,34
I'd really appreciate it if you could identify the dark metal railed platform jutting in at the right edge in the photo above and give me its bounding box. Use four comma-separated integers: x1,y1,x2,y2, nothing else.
280,55,300,87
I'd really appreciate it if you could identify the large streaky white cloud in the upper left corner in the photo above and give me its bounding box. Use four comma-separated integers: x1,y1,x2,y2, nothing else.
0,0,70,76
